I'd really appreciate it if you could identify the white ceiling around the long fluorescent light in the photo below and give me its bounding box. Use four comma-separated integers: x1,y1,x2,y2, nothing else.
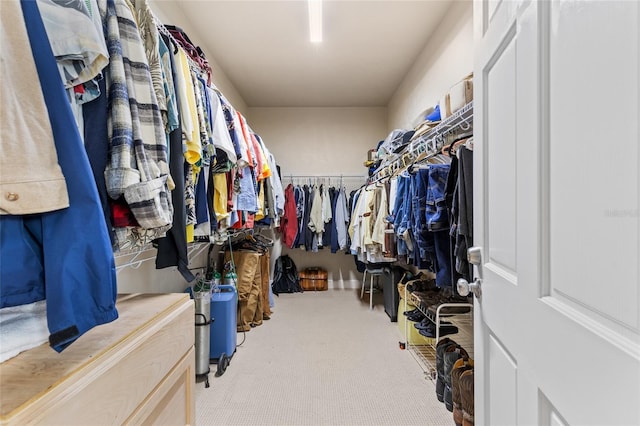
152,0,453,107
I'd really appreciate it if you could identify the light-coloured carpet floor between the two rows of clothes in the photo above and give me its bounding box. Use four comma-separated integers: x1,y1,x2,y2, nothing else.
196,290,453,426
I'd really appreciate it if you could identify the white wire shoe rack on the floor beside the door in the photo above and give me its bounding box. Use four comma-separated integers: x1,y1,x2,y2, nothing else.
404,287,474,380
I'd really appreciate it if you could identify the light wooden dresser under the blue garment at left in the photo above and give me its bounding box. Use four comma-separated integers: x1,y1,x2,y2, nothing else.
0,293,195,425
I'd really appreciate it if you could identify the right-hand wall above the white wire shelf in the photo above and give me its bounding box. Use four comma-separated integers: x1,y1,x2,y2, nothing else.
387,0,473,130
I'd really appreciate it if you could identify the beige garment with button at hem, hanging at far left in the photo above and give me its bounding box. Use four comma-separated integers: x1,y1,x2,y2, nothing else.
0,2,69,215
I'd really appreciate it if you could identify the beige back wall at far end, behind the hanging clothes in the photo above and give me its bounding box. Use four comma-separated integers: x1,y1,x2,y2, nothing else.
249,107,387,288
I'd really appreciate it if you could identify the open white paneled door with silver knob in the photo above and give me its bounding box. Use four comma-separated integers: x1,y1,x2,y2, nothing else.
474,0,640,425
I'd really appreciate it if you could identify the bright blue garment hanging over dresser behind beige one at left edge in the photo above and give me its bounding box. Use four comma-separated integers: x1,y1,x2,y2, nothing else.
0,0,118,352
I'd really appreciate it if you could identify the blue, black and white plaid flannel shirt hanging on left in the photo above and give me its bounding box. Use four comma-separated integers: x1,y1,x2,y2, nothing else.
100,0,173,241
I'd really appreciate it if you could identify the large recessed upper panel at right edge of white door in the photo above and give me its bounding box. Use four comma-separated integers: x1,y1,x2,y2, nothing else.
548,2,640,331
